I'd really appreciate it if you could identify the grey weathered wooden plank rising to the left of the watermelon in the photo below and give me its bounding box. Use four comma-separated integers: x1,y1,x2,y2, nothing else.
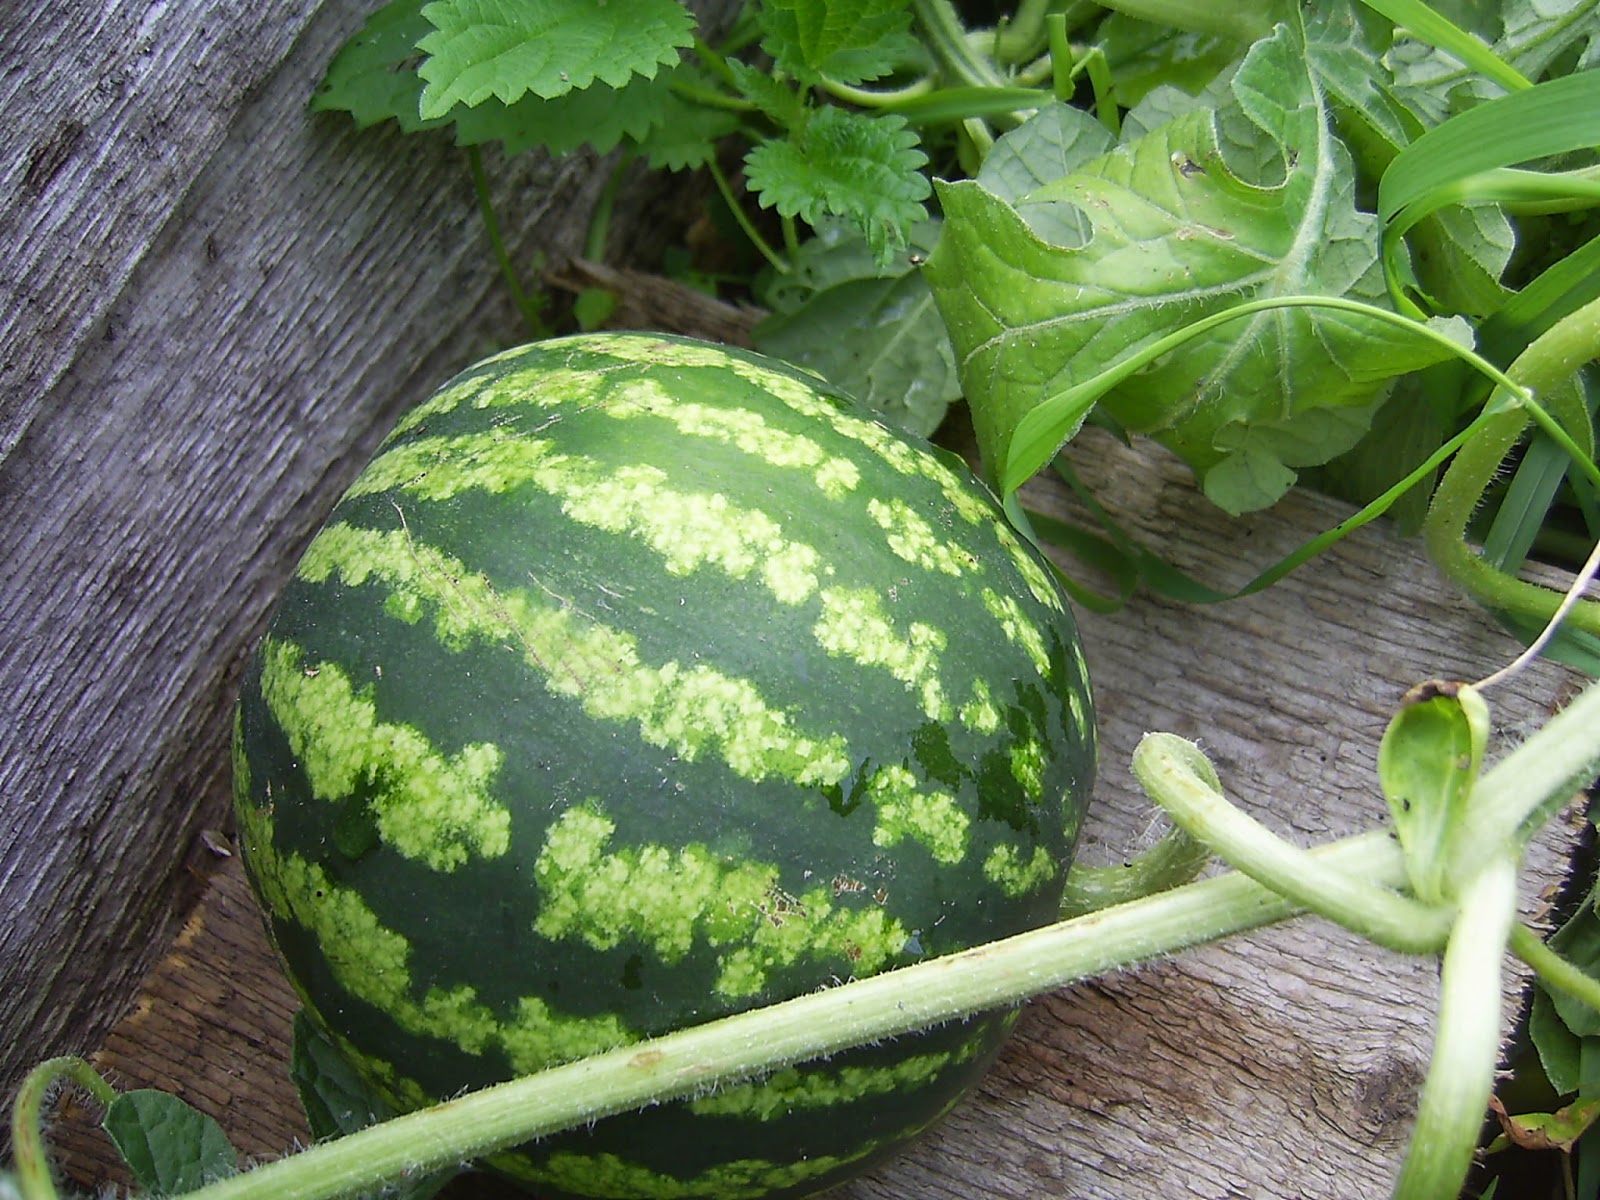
0,0,734,1094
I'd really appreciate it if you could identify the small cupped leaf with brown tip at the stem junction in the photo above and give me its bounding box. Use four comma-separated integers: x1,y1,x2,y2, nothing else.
1378,683,1490,904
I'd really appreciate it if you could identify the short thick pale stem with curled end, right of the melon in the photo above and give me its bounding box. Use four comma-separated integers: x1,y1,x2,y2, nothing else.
1133,733,1454,954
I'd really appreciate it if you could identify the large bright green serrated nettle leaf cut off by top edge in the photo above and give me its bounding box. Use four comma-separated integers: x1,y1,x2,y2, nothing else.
418,0,694,120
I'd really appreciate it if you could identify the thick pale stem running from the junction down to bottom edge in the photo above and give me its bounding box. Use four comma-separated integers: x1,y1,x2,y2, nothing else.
1394,858,1517,1200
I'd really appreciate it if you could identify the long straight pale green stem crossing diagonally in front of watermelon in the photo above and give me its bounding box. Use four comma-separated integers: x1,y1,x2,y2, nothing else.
172,834,1405,1200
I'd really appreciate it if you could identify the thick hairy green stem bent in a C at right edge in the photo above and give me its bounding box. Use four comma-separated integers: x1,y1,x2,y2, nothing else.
1422,301,1600,634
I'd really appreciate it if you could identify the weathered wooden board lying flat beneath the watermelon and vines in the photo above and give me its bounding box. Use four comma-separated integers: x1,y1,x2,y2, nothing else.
43,419,1573,1200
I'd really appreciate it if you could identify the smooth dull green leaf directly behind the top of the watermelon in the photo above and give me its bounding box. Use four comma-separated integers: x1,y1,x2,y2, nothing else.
752,221,962,435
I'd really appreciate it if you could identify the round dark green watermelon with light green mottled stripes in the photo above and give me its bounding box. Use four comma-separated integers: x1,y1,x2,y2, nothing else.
234,333,1094,1200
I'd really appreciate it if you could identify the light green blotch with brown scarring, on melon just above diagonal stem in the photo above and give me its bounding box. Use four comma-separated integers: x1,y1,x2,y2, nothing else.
534,802,907,997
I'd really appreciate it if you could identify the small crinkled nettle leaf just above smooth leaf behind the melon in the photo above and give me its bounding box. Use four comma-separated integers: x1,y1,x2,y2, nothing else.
744,107,931,262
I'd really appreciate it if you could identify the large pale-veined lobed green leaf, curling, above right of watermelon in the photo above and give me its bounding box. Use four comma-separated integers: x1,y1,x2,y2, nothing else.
928,16,1445,512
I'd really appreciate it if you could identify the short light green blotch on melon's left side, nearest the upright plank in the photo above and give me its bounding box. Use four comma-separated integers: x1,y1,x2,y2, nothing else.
261,637,510,870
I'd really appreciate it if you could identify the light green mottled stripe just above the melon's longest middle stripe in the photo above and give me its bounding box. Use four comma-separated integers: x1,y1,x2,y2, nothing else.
349,429,821,605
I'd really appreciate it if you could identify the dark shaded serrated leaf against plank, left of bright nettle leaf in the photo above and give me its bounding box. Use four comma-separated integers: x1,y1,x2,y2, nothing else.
310,0,446,133
